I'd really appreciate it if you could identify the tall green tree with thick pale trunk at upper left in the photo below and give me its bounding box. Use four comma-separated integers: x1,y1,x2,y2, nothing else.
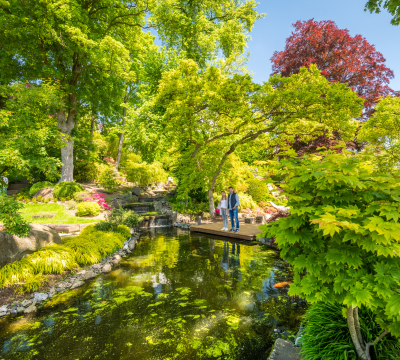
0,0,151,181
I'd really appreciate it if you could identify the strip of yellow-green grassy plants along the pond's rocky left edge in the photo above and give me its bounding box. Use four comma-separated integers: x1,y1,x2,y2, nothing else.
0,225,130,291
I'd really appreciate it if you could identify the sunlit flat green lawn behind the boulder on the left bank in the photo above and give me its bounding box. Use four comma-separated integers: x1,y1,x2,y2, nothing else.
21,204,102,224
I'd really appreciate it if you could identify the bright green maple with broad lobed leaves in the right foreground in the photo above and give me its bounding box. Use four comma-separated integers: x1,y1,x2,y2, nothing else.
261,145,400,360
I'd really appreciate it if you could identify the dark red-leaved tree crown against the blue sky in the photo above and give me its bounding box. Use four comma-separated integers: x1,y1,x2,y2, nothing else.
271,19,394,120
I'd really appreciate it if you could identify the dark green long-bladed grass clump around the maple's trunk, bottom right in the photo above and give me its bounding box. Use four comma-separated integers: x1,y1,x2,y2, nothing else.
301,303,400,360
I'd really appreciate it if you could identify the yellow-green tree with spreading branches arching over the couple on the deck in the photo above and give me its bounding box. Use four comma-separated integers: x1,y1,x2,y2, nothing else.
156,60,362,216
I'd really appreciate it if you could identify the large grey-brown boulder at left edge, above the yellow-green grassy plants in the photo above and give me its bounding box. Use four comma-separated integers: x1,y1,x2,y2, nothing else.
0,224,62,267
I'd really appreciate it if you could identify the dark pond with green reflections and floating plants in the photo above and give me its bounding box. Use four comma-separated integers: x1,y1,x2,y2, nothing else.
0,228,304,360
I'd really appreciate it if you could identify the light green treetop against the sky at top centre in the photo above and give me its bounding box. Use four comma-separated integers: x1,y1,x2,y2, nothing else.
149,0,264,68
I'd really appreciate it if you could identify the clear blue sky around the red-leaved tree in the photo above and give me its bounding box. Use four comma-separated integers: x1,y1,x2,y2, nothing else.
247,0,400,90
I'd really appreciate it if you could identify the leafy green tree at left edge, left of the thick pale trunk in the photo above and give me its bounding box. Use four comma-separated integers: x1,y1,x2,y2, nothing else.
0,82,63,180
